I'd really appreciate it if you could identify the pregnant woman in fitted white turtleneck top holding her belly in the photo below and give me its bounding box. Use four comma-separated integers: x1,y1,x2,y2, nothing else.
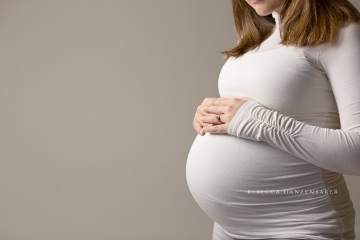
186,0,360,240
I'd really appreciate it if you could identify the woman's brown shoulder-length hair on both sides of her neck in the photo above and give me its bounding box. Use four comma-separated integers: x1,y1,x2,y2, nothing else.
223,0,360,57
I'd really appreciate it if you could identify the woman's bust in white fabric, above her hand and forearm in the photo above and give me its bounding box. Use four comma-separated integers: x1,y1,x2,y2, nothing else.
219,45,336,120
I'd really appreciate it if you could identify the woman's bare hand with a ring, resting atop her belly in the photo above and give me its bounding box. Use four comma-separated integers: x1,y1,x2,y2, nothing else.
193,98,247,136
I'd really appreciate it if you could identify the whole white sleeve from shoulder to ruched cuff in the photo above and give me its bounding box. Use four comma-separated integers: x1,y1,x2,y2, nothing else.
228,23,360,175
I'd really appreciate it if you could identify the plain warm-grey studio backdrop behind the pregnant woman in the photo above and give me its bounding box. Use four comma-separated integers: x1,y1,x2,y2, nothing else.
0,0,360,240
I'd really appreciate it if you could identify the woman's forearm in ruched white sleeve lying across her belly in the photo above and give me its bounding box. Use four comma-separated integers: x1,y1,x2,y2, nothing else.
228,101,360,175
